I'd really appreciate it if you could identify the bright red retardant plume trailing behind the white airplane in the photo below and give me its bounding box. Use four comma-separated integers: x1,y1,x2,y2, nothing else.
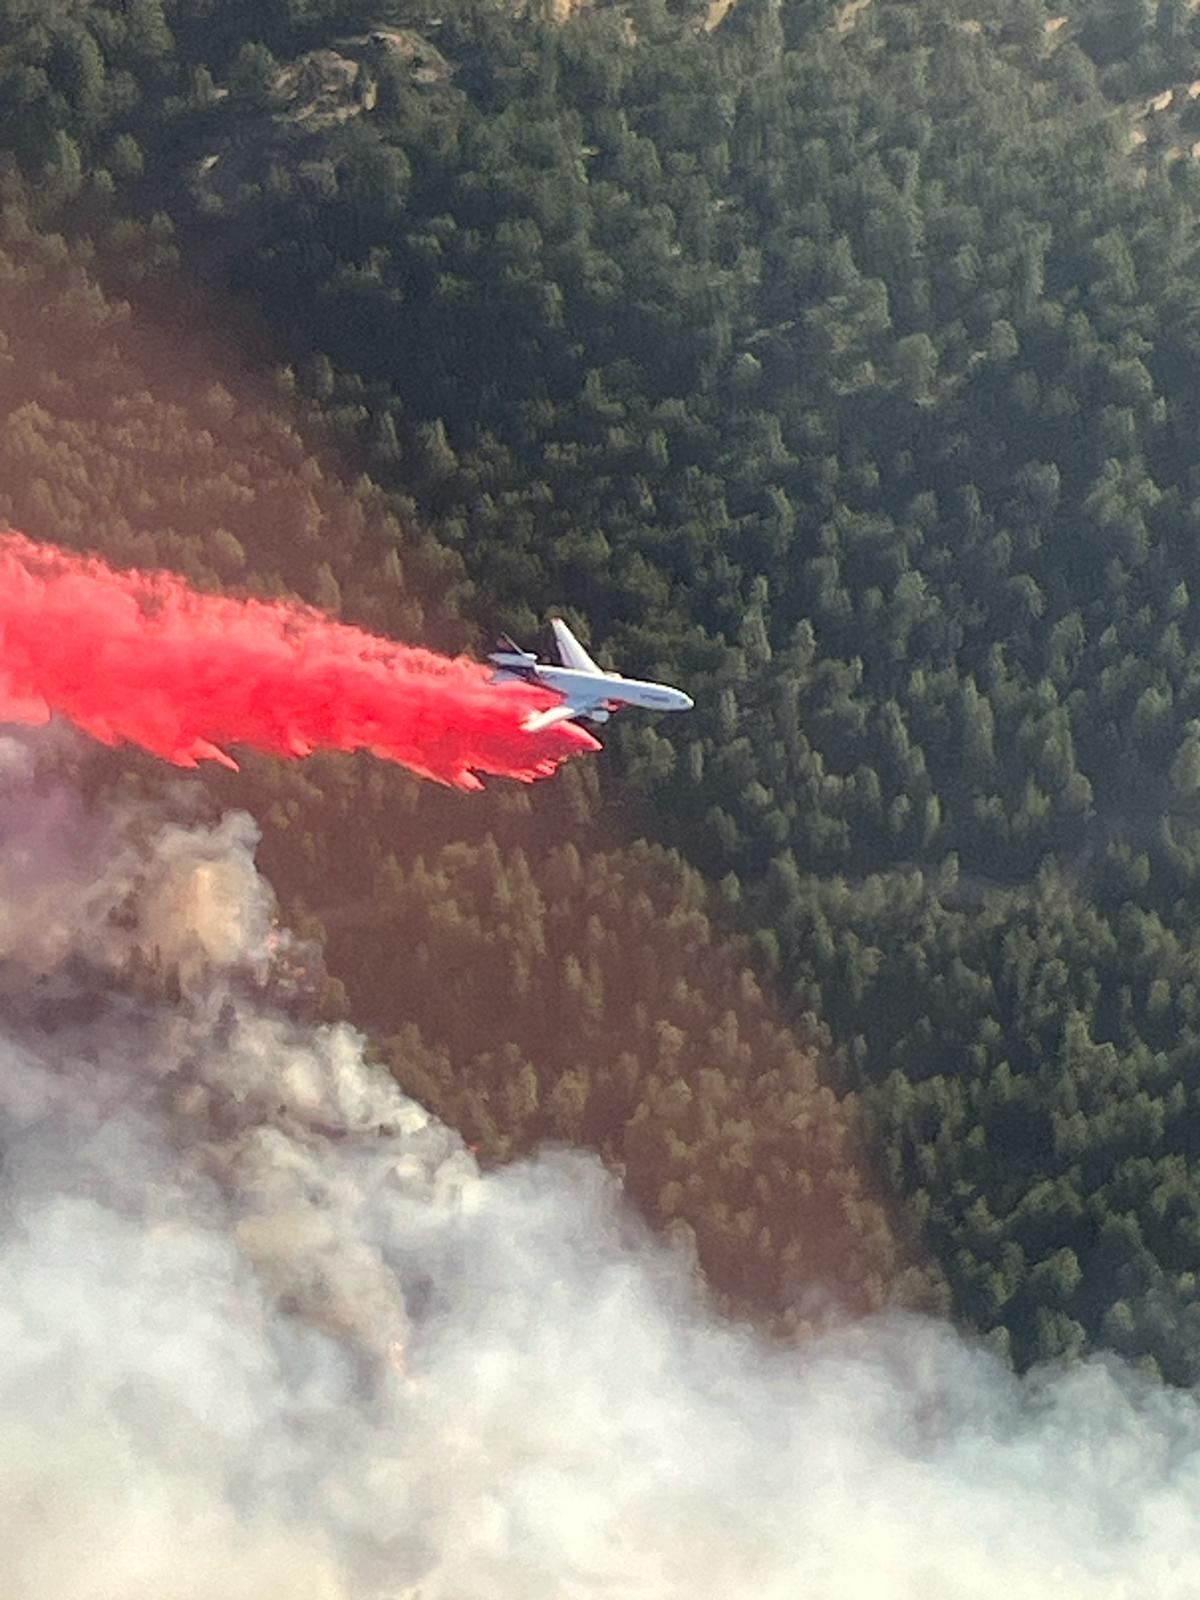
0,533,600,789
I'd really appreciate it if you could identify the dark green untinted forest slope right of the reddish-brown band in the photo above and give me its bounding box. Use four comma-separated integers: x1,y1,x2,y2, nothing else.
6,0,1200,1381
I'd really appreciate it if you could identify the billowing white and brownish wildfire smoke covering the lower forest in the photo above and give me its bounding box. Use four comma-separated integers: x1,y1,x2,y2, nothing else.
0,736,1200,1600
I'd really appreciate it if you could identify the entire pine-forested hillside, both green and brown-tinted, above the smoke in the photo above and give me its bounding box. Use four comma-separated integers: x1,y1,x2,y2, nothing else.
11,0,1200,1382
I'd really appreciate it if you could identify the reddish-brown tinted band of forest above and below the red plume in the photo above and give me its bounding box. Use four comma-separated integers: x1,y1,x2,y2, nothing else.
0,211,915,1330
